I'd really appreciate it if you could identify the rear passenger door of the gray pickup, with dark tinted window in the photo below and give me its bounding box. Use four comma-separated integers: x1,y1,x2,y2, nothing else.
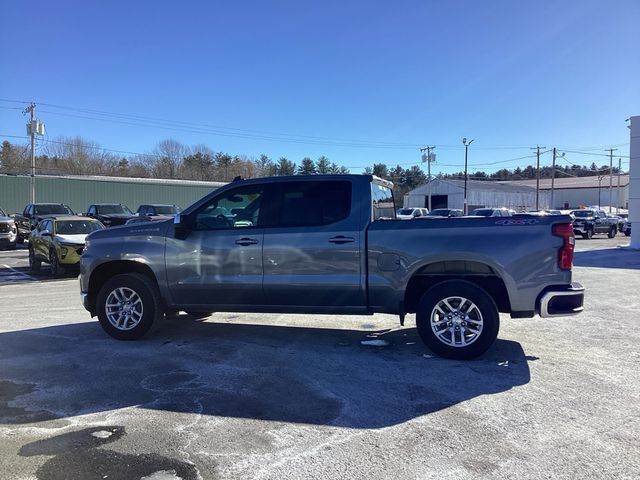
263,178,366,311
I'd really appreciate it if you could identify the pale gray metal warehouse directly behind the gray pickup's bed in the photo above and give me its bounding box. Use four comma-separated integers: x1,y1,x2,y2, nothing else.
404,179,550,211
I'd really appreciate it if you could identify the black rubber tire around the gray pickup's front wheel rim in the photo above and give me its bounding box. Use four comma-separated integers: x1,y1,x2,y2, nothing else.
96,273,163,340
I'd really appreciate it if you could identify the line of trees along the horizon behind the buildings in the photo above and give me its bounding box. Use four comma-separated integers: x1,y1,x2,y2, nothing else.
0,137,618,198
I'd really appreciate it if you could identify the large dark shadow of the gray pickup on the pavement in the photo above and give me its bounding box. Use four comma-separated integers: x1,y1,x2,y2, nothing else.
0,313,536,429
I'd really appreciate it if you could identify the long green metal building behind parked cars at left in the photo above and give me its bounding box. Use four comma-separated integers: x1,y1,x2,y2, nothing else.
0,175,224,213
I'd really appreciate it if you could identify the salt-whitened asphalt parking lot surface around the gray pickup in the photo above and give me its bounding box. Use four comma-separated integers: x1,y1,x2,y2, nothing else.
0,236,640,480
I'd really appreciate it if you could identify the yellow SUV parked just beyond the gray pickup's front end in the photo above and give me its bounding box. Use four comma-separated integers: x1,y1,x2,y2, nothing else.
29,216,104,277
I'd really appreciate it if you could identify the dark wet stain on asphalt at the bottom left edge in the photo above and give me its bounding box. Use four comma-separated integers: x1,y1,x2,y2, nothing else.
19,426,200,480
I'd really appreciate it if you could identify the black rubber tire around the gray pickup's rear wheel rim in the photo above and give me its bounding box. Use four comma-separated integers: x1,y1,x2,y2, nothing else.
416,280,500,360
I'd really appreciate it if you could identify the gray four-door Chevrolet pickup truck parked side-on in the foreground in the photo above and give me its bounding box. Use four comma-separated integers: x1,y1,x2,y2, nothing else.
80,175,584,358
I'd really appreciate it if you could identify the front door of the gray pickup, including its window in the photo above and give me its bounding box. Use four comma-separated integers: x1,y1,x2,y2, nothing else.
166,185,264,308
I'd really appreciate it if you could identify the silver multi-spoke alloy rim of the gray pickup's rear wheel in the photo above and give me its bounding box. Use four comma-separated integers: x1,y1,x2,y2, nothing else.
430,297,483,347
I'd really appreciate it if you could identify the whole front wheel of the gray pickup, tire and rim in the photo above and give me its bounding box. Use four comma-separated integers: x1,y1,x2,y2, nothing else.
96,273,161,340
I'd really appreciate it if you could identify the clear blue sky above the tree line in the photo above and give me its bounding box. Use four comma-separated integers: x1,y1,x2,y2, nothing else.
0,0,640,173
